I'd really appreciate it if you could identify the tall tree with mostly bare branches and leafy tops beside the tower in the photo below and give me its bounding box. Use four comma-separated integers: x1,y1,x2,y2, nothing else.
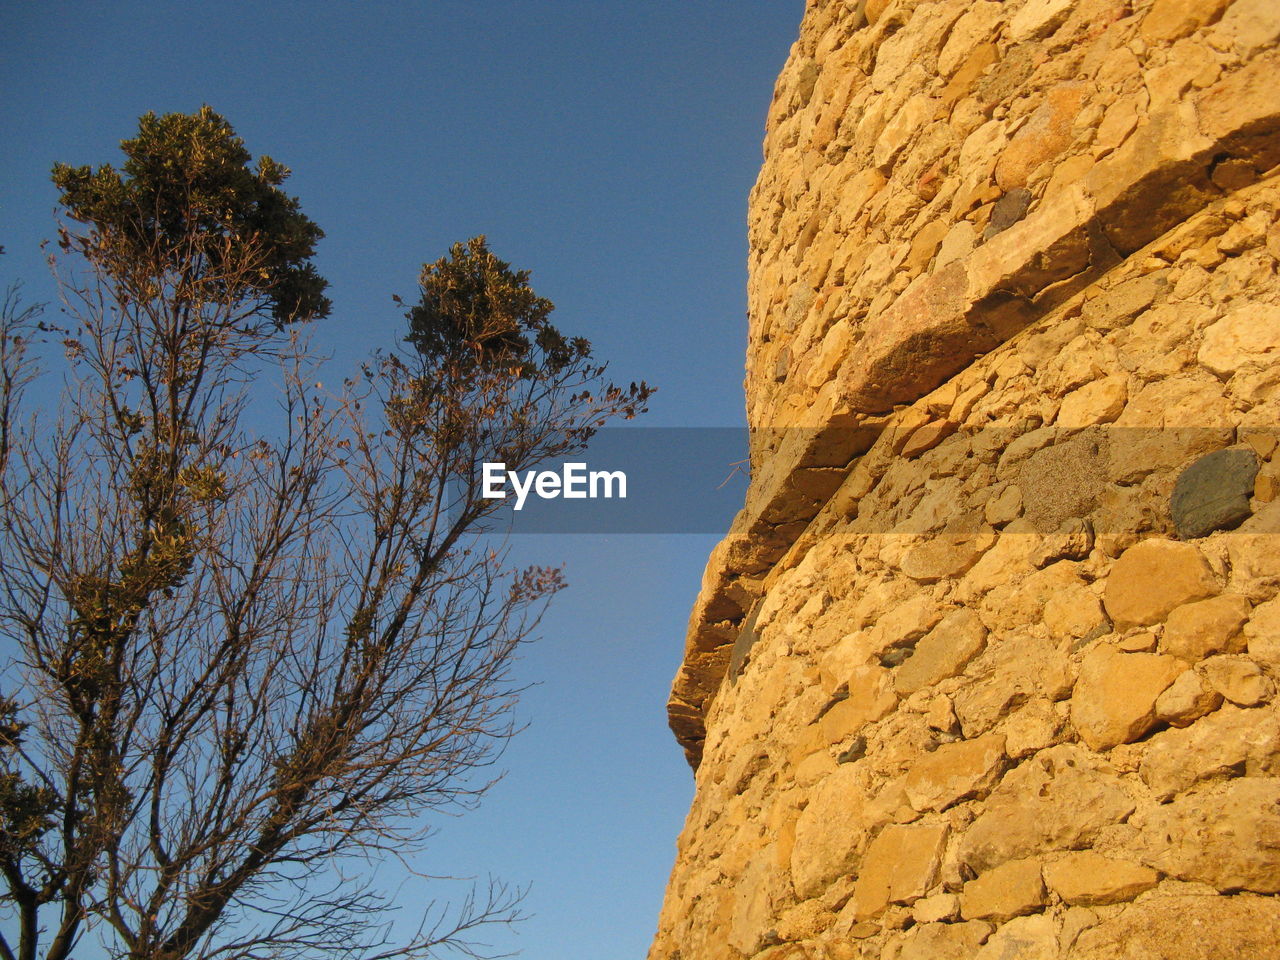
0,108,650,960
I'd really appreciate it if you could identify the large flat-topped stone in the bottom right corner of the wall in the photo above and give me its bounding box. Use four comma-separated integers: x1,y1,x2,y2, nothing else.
1070,896,1280,960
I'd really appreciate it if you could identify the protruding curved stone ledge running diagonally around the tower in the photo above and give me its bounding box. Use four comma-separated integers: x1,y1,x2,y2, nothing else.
668,51,1280,768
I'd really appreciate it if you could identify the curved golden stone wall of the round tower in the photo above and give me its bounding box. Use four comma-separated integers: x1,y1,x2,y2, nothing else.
650,0,1280,960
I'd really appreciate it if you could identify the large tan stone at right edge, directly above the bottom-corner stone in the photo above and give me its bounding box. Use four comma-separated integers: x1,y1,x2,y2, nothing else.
1142,777,1280,893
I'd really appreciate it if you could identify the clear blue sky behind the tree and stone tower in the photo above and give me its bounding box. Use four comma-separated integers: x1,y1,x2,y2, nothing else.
0,0,804,960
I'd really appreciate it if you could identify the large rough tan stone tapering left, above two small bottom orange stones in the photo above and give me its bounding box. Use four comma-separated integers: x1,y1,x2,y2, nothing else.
959,744,1134,872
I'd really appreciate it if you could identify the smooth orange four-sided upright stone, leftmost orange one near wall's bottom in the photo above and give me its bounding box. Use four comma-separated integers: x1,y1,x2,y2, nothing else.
850,823,947,920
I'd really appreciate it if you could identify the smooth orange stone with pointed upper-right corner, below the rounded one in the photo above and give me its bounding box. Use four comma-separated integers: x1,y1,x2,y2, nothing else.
1071,644,1187,750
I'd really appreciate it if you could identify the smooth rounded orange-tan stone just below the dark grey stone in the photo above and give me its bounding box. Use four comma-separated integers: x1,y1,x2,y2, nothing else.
1103,539,1219,628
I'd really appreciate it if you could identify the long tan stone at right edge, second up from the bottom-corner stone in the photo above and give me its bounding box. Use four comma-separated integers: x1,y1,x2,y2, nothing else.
1139,707,1280,800
